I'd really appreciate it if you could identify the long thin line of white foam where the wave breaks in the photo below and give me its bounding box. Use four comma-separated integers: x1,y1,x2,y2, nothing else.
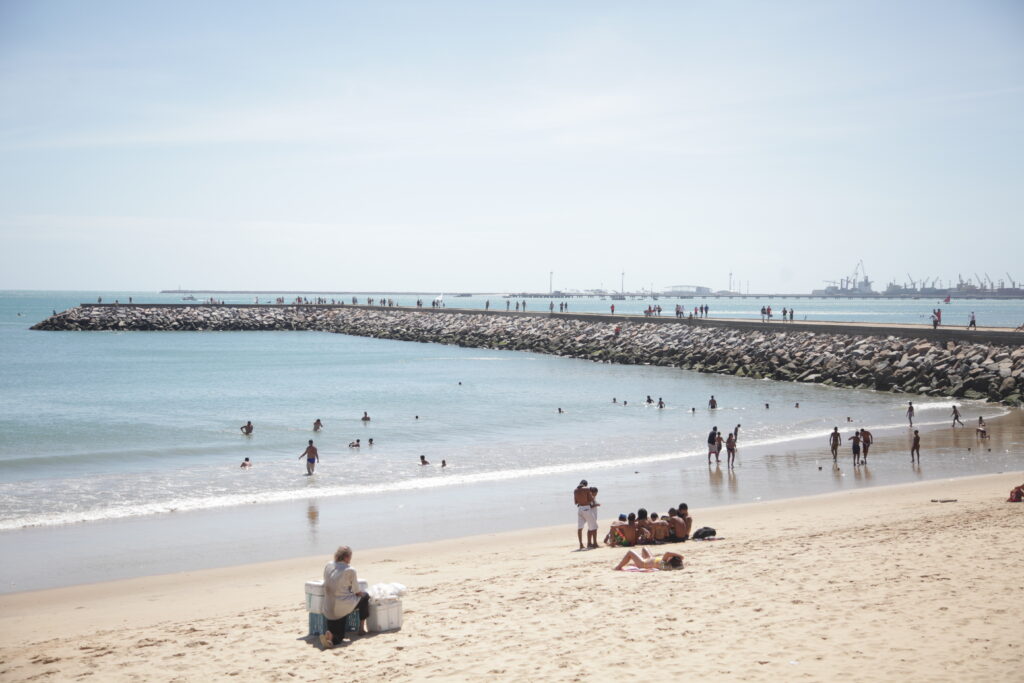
0,409,1009,530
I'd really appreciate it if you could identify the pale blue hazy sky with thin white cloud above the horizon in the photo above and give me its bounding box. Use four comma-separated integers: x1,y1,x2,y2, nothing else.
0,0,1024,292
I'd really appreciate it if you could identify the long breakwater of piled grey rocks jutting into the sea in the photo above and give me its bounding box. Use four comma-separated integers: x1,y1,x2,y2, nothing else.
33,305,1024,405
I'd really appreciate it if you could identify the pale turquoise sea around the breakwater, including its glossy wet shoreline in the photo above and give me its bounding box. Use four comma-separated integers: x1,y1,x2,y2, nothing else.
0,292,1024,592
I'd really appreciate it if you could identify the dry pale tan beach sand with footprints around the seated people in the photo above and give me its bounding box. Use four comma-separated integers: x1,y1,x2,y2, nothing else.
0,465,1024,681
